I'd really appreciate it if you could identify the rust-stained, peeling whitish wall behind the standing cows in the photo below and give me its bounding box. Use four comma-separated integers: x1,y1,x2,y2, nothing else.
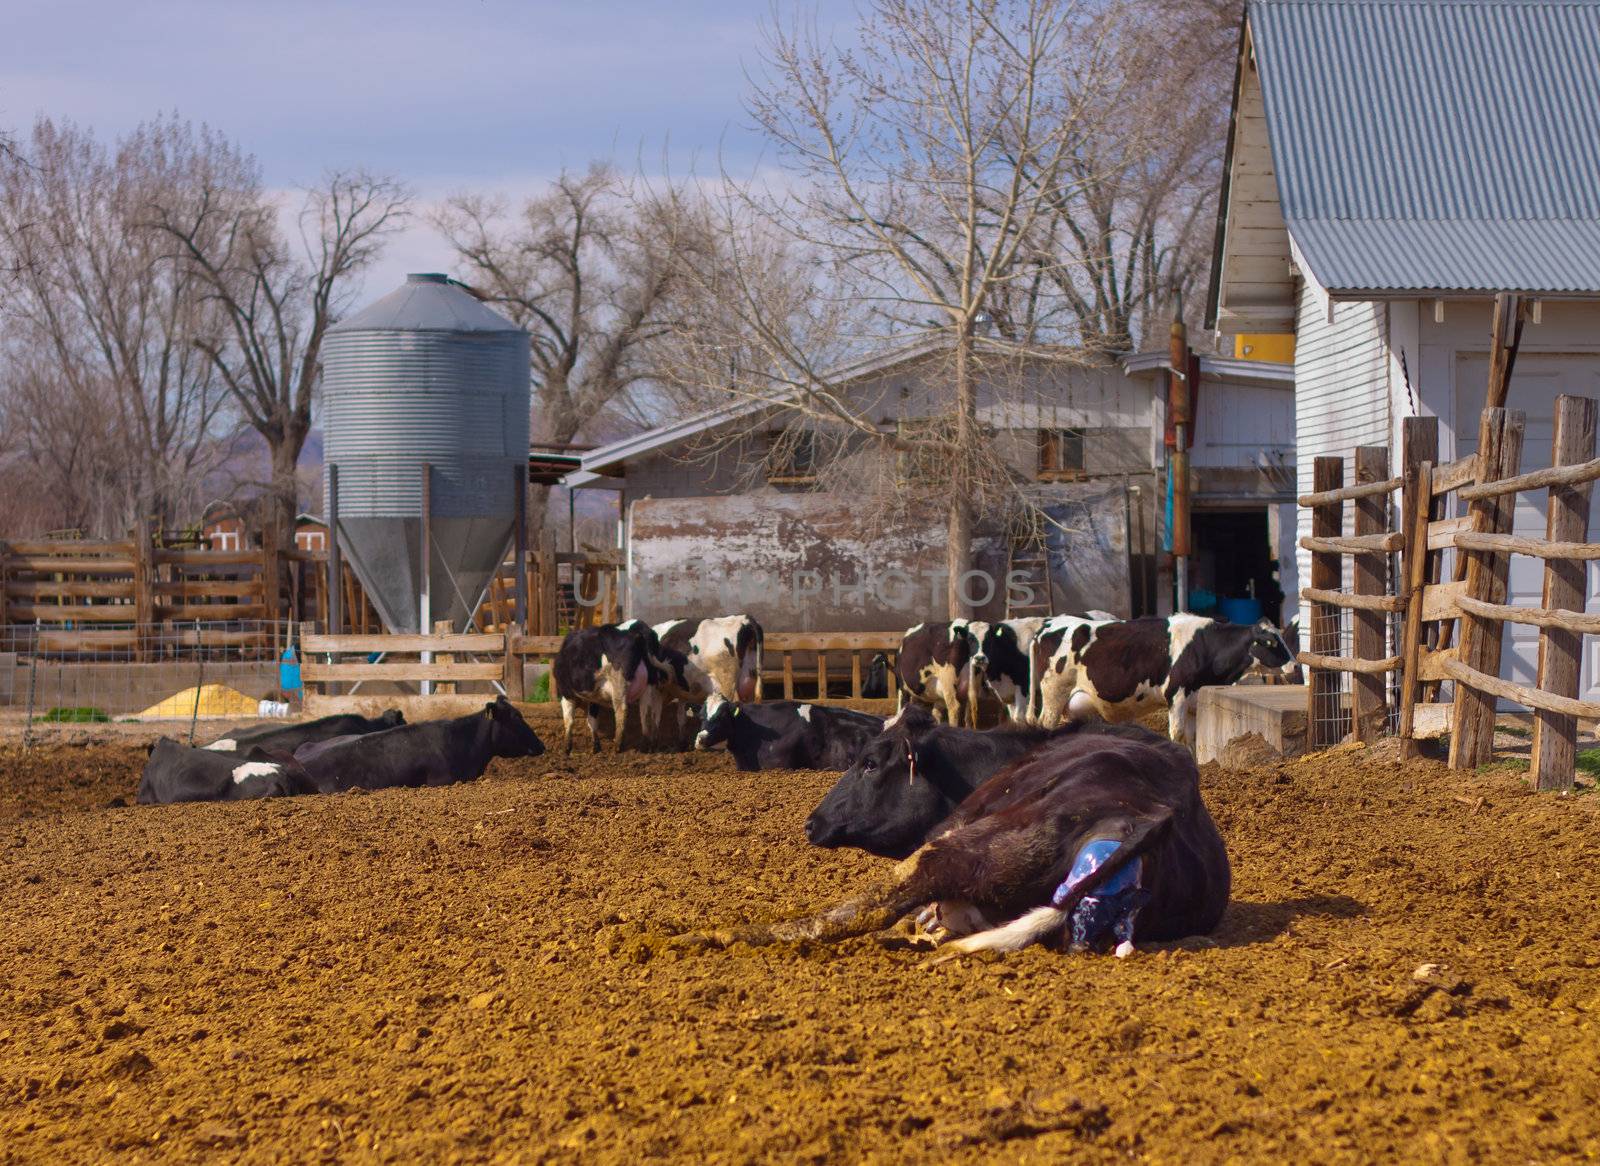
626,493,1005,632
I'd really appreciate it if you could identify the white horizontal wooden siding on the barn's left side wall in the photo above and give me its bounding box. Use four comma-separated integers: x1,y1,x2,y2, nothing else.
1294,280,1389,584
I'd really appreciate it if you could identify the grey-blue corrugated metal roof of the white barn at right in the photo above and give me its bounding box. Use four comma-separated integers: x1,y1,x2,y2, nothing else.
1250,0,1600,293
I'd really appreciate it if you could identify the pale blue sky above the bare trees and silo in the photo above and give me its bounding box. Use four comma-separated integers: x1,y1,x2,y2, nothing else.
0,0,854,300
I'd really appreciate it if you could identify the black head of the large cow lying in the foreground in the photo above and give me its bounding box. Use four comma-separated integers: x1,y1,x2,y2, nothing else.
805,705,966,859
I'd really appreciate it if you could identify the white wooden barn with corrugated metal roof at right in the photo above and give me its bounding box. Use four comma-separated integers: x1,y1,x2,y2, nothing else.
1208,0,1600,699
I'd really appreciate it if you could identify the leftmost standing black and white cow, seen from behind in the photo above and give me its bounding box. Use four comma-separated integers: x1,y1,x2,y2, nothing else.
550,619,669,753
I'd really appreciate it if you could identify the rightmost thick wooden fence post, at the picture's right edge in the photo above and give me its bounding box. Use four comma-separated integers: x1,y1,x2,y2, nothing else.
1531,397,1597,790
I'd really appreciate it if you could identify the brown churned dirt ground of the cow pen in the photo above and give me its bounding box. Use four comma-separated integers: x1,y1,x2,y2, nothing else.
0,703,1600,1163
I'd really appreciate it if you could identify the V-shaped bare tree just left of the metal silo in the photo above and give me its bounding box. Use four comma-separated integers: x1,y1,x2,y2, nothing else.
150,145,410,529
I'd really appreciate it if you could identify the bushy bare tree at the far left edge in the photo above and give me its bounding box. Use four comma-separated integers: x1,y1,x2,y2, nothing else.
0,118,226,533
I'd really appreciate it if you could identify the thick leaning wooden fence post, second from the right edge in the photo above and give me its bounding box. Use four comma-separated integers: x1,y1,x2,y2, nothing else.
1450,409,1525,769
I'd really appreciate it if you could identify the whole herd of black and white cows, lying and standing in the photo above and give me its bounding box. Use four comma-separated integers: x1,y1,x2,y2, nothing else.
138,613,1293,960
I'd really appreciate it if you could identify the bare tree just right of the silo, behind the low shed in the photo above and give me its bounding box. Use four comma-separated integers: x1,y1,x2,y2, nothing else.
435,162,706,526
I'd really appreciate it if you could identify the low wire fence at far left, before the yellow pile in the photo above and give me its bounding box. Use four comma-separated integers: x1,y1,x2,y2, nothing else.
0,619,304,726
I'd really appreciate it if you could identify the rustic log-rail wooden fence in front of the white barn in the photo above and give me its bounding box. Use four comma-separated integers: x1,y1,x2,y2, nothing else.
1301,397,1600,789
